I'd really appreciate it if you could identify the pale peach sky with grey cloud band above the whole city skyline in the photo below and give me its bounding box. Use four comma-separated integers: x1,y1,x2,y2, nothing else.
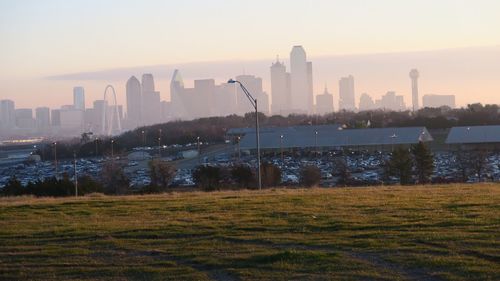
0,1,500,108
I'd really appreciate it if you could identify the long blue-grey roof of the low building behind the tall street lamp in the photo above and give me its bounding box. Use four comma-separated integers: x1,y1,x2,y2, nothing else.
236,126,433,149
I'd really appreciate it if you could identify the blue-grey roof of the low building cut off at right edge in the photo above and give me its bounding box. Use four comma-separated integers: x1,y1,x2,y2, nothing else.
446,125,500,144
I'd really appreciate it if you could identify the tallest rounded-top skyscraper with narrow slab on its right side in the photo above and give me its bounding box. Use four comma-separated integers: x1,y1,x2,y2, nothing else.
290,46,313,113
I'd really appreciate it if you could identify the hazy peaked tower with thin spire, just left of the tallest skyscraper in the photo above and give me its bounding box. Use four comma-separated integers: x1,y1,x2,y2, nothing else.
271,59,291,115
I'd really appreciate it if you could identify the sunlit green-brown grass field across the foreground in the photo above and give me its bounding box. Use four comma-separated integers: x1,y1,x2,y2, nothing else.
0,184,500,280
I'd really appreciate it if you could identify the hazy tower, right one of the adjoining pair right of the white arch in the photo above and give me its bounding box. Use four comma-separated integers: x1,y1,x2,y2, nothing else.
141,74,161,125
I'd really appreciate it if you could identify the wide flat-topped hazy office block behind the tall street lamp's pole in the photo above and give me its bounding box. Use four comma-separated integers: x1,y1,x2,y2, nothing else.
236,75,269,115
